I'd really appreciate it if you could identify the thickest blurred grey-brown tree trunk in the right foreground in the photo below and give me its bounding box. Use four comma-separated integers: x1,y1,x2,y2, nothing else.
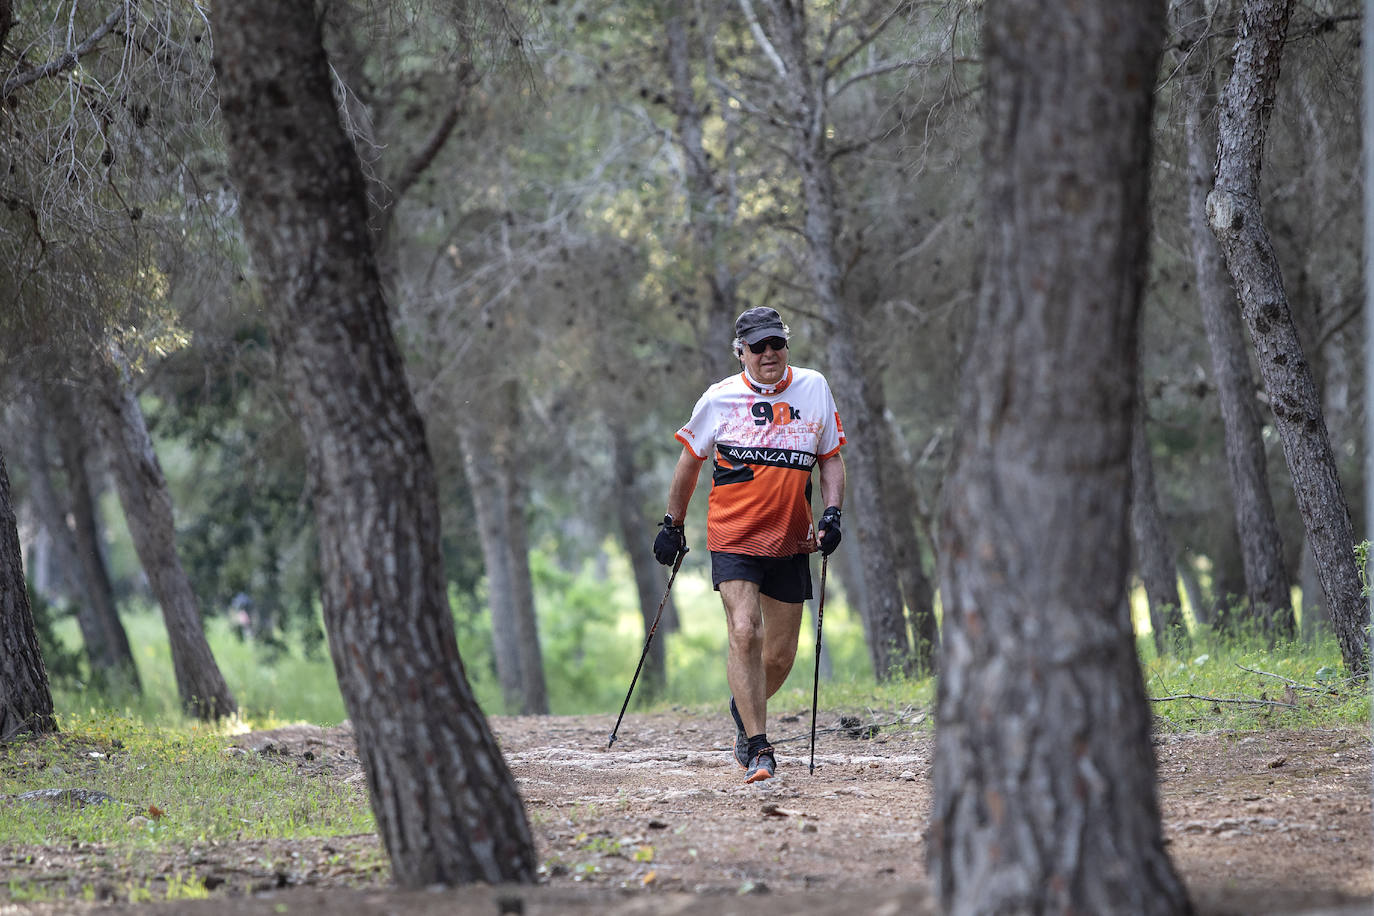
930,0,1190,915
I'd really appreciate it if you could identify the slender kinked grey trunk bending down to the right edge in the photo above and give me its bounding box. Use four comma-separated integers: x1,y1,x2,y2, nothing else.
1206,0,1370,674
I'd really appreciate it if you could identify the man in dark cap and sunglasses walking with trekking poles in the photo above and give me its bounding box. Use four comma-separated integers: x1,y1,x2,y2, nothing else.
654,308,845,783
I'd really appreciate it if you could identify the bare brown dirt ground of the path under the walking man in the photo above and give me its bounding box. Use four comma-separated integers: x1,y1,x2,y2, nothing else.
0,709,1374,916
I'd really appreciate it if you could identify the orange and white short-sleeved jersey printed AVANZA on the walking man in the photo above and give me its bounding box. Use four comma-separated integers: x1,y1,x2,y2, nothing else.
676,367,845,556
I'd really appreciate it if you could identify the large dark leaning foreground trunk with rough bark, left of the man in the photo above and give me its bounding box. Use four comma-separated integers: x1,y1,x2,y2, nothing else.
212,0,536,887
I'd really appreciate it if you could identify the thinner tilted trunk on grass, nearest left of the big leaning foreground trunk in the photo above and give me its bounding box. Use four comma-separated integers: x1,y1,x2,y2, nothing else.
89,353,238,720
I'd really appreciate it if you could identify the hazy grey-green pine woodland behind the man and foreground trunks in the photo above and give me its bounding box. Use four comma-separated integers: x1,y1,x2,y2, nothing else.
4,3,1363,710
